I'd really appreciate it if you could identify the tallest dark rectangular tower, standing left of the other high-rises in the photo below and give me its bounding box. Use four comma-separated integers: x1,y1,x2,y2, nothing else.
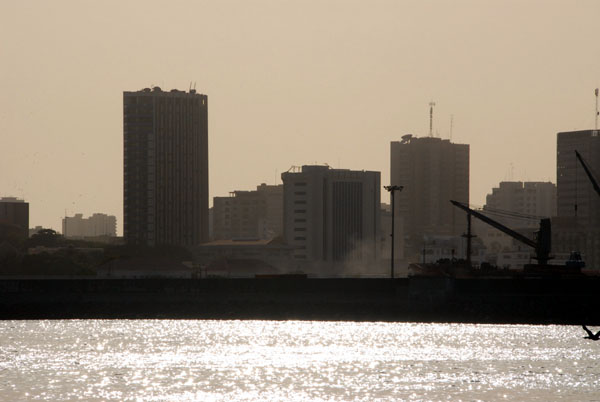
123,87,208,246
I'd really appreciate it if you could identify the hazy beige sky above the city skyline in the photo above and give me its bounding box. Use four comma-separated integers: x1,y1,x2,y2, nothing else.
0,0,600,233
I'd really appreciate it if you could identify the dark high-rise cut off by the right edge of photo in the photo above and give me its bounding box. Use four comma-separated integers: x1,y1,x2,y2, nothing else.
552,130,600,269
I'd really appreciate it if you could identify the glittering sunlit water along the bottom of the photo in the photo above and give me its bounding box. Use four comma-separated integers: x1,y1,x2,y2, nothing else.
0,320,600,401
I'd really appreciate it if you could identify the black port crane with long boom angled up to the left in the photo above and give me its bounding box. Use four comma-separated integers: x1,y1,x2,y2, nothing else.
450,200,552,265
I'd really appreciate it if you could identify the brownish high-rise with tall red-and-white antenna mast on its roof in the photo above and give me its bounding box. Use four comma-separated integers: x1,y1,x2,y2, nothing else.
391,134,469,259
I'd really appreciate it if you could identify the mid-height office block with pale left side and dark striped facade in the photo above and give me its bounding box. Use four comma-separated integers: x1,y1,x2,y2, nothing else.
281,166,381,266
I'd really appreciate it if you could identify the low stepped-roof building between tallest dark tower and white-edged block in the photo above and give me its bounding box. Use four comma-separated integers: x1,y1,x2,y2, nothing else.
213,183,283,240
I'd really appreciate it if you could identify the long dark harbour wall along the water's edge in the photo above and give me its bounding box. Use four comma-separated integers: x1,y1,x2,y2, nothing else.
0,277,600,325
